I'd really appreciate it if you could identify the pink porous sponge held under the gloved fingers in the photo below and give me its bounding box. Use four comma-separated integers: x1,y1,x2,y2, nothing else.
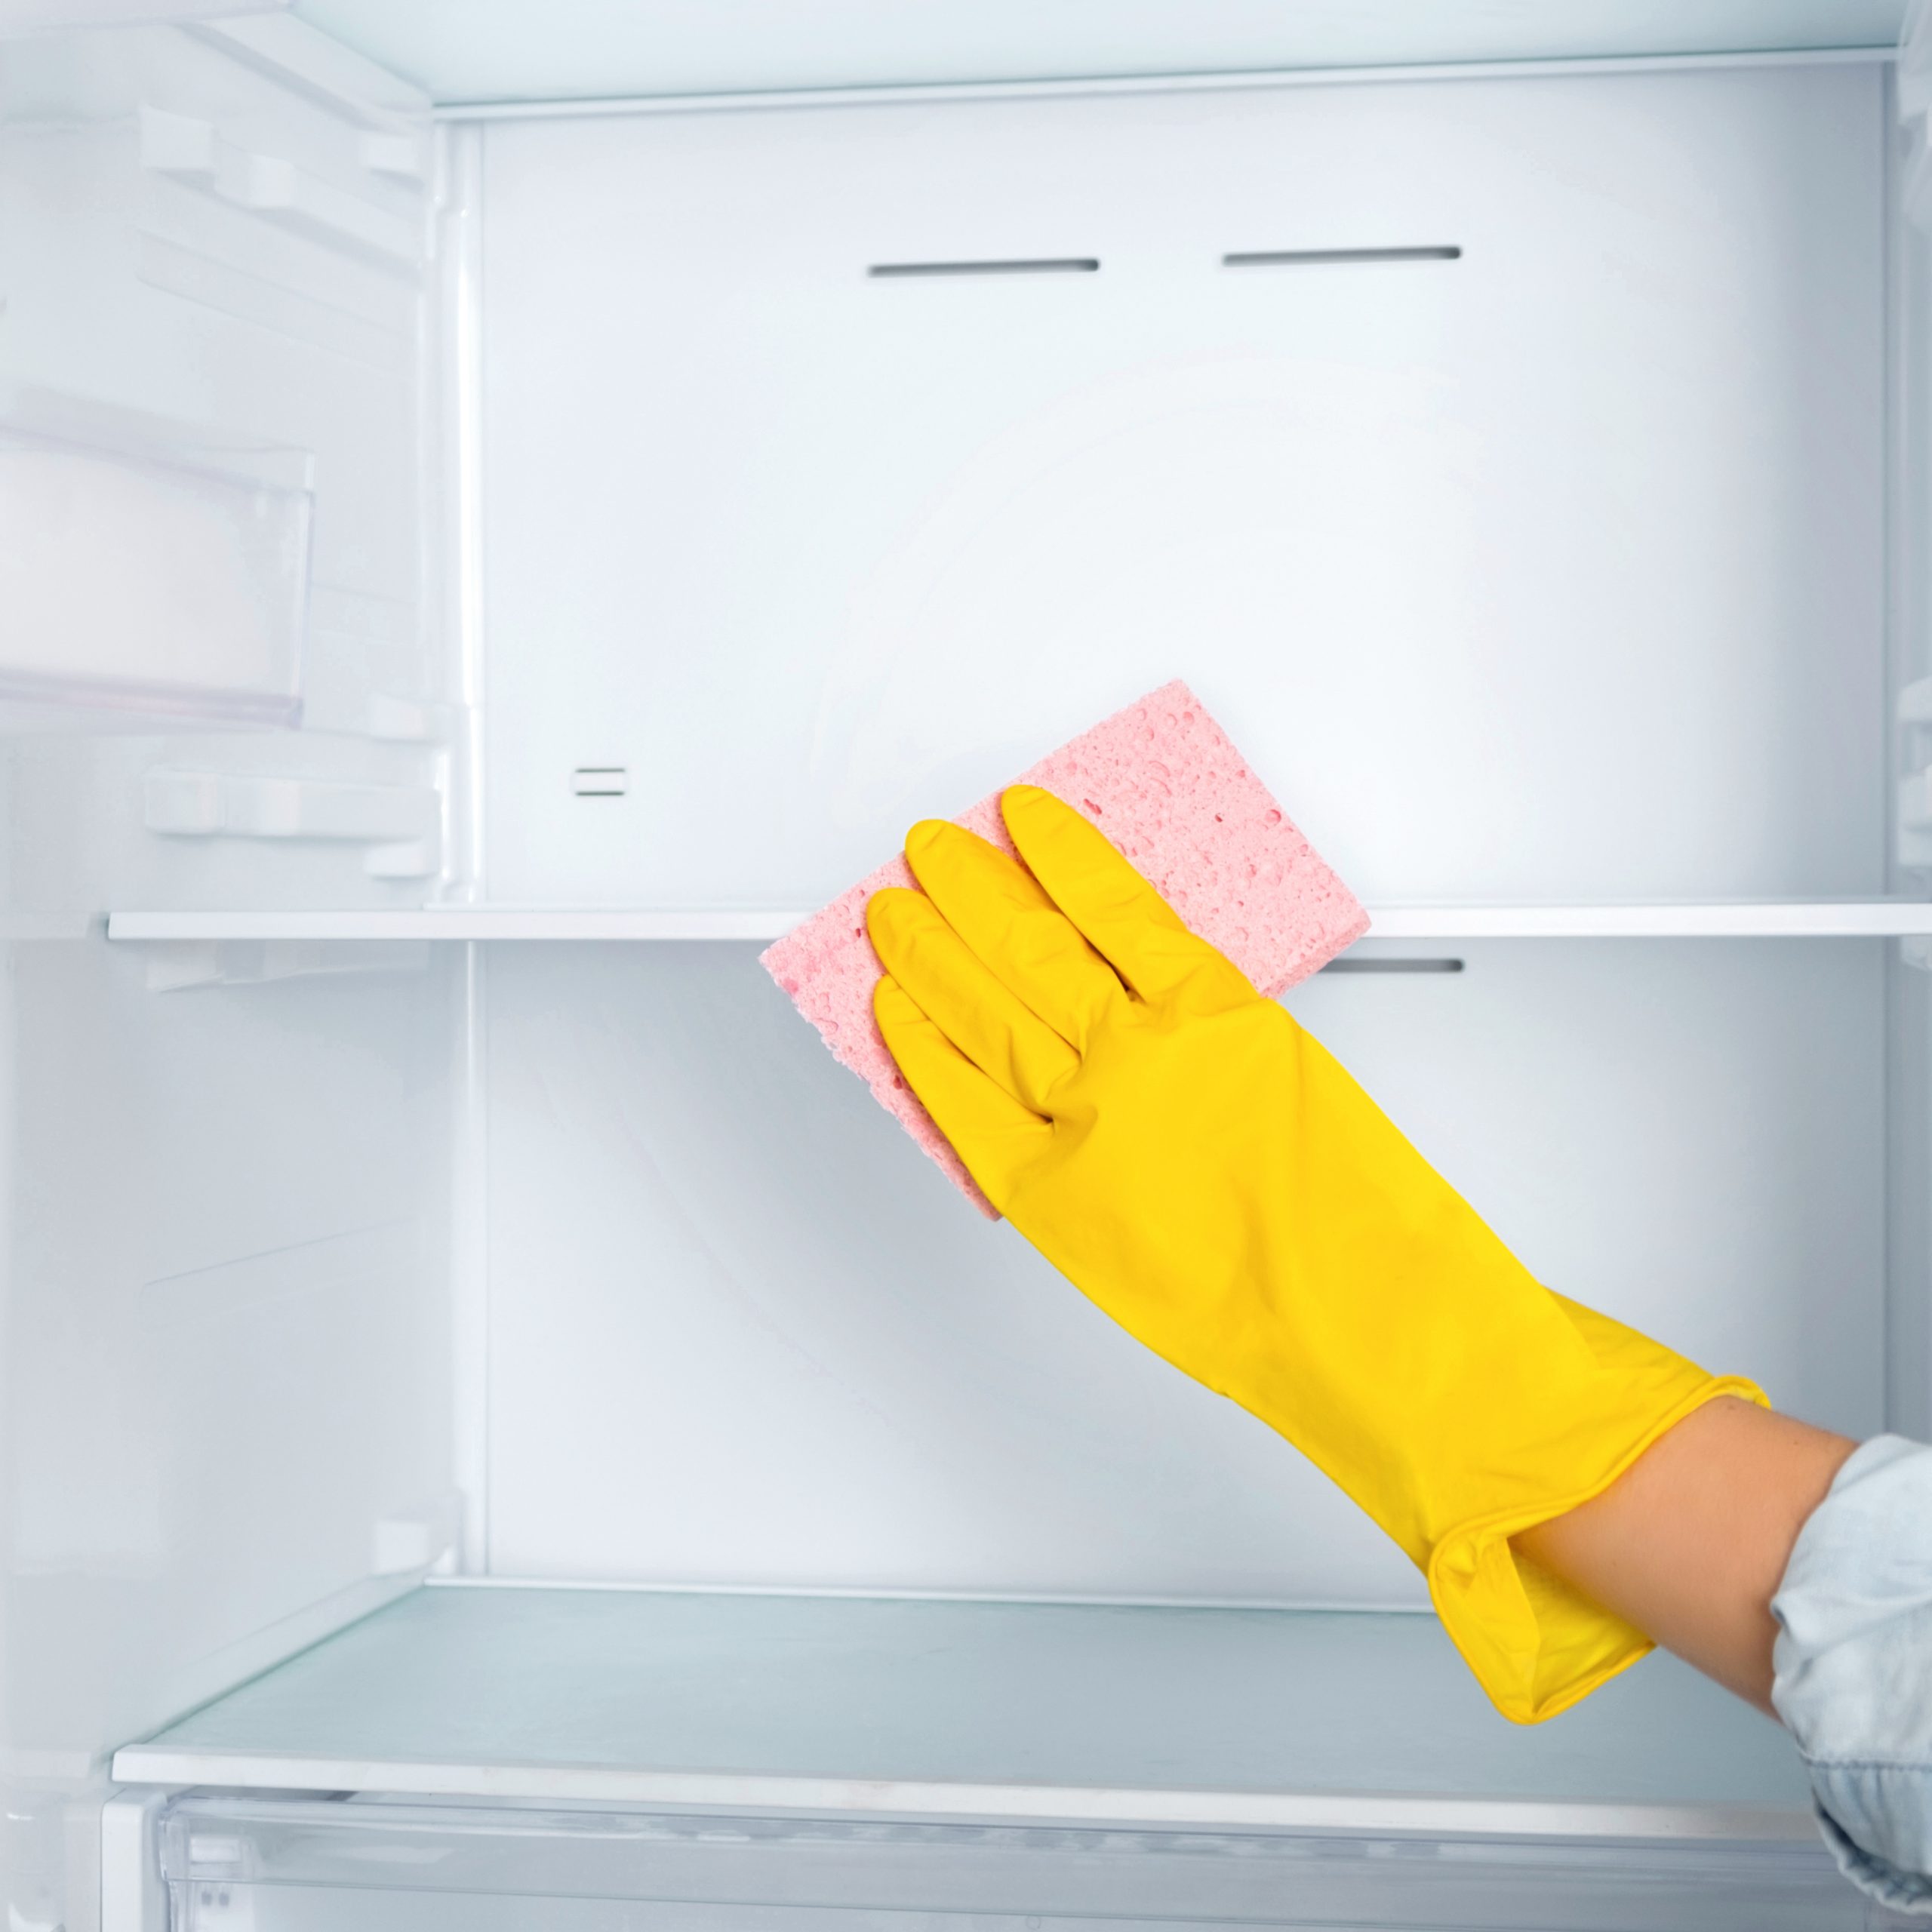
763,682,1367,1215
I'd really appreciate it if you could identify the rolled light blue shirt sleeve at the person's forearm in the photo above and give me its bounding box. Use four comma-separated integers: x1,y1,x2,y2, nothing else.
1772,1435,1932,1915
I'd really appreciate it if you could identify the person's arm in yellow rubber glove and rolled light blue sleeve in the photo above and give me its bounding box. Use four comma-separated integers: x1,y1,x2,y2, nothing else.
867,788,1932,1909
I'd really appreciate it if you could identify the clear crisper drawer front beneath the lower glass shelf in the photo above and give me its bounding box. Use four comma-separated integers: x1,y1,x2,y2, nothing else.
160,1793,1905,1932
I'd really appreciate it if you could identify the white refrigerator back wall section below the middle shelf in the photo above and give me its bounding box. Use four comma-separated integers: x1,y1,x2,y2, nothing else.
487,939,1886,1605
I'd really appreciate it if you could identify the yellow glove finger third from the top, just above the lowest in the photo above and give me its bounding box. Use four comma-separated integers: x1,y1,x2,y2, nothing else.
866,887,1080,1113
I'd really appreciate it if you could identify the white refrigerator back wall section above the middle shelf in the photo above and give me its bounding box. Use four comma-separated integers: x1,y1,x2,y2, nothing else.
475,66,1886,906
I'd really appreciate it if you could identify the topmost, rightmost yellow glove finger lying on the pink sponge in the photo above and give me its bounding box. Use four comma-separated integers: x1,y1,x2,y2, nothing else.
999,784,1256,1004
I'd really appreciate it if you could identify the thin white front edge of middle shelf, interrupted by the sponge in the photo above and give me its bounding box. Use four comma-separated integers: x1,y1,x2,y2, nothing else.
108,898,1932,941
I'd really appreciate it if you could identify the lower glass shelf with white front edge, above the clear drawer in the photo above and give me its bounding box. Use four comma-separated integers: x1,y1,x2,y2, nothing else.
114,1583,1814,1843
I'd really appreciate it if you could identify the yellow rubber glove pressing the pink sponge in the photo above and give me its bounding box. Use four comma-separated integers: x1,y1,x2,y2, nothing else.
867,786,1764,1724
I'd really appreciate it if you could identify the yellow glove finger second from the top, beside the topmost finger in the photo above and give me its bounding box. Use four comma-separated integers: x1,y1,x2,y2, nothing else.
906,819,1122,1051
